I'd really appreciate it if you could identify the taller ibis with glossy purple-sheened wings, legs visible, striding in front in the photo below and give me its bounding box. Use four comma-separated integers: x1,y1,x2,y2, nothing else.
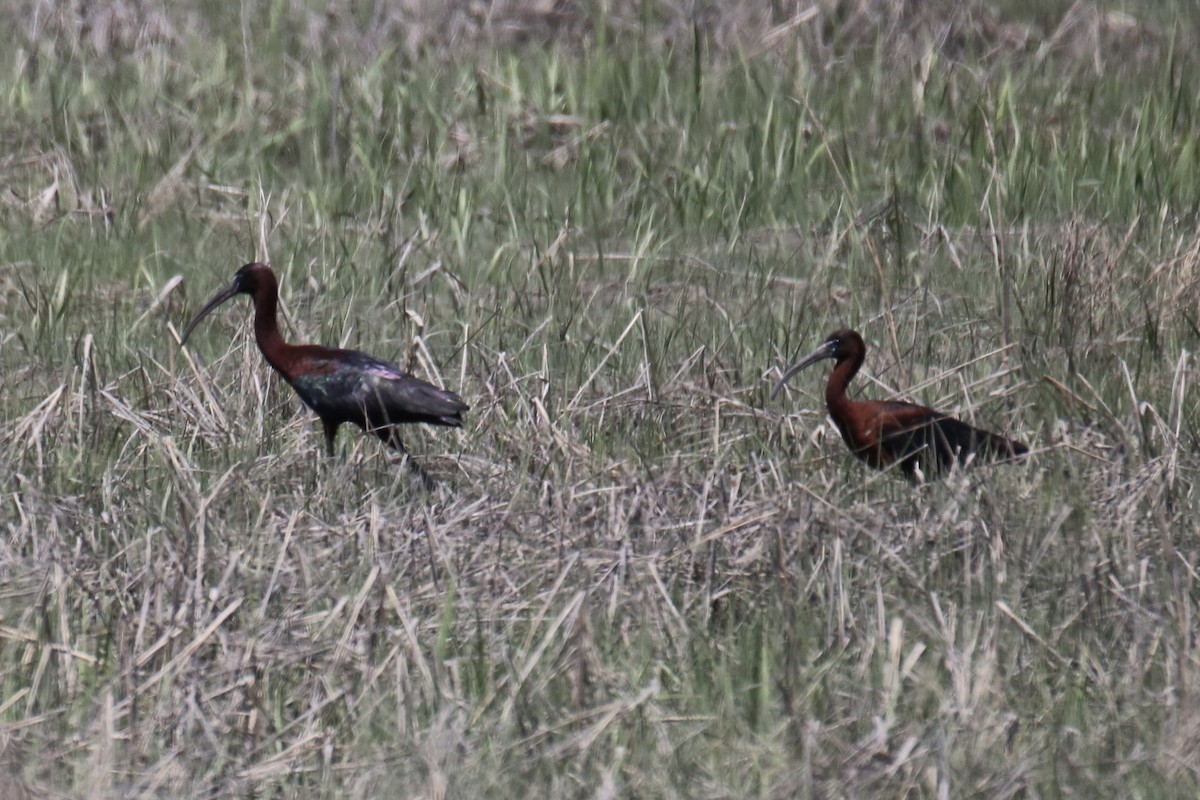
180,264,470,482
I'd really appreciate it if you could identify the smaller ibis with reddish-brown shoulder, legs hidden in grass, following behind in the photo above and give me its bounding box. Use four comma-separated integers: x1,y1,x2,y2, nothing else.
770,331,1030,482
